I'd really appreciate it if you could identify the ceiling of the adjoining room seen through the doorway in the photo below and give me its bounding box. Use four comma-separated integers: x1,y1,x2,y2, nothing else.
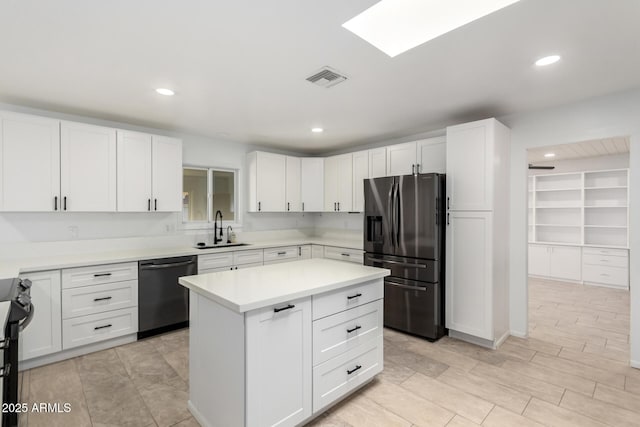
527,136,629,163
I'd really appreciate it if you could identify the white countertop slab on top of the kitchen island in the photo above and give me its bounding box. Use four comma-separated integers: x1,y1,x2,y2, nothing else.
178,259,390,313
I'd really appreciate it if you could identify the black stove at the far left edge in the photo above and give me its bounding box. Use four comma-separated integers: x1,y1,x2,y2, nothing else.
0,279,34,427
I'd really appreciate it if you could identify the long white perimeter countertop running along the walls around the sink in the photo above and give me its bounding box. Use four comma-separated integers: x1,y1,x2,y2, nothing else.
0,237,362,279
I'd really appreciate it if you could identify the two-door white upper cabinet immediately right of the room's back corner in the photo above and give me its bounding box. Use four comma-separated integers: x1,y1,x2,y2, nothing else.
324,153,353,212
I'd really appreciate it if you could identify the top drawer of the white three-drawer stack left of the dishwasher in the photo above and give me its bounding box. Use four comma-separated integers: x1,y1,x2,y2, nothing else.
62,262,138,289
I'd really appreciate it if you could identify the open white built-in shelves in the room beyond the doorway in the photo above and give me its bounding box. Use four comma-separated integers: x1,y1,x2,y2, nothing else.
529,169,629,248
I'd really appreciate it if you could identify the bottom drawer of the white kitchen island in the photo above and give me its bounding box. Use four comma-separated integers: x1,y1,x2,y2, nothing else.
313,335,384,413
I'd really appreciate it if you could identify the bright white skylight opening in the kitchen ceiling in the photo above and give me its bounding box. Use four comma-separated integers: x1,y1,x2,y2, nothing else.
342,0,519,58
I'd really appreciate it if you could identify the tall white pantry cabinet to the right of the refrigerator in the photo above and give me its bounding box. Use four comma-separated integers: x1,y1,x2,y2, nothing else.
445,119,510,348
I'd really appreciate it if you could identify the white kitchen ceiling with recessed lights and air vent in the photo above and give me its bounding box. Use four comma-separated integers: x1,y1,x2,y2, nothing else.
0,0,640,153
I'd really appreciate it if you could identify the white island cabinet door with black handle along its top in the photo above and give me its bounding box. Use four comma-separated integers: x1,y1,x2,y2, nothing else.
245,297,312,426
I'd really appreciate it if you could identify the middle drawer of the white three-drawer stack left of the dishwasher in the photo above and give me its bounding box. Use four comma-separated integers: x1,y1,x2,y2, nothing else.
62,280,138,319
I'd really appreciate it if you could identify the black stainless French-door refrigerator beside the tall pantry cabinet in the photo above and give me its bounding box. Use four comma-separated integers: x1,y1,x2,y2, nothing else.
364,173,446,341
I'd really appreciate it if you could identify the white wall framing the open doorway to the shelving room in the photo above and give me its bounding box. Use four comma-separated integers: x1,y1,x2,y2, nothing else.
499,90,640,367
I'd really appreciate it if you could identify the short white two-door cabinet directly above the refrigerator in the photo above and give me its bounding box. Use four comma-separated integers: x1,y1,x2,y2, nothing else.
387,136,447,176
